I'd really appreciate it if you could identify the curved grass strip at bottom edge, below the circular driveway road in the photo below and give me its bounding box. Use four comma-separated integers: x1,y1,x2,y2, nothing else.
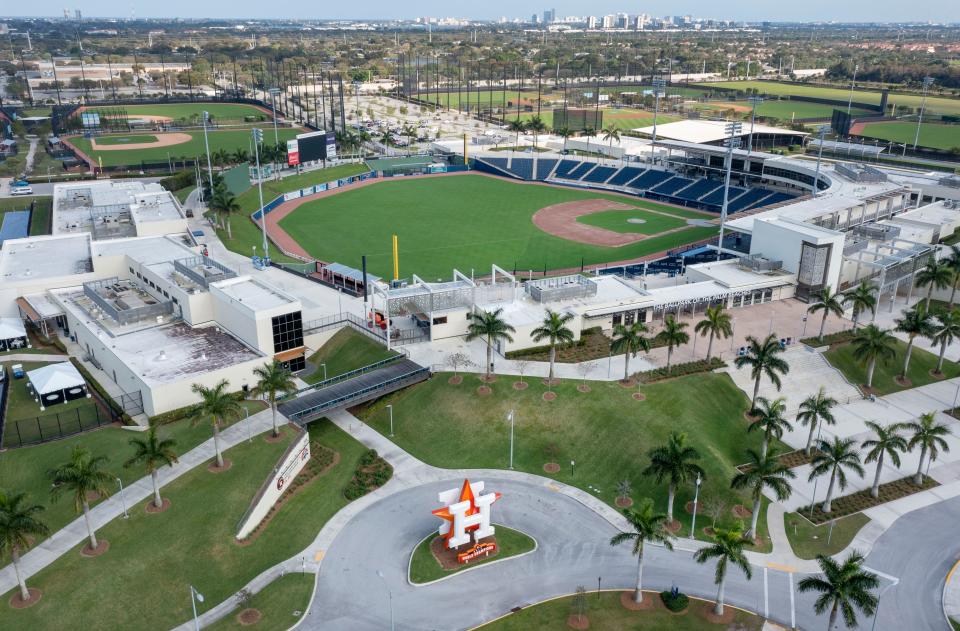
481,585,763,631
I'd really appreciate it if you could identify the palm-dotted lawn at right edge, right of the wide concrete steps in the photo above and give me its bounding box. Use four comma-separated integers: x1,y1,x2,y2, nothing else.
824,340,960,395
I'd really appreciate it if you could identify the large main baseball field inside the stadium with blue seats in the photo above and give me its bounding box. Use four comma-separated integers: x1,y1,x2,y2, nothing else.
268,174,717,279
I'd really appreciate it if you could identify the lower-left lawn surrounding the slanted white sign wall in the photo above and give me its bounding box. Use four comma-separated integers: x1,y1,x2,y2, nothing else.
0,422,378,631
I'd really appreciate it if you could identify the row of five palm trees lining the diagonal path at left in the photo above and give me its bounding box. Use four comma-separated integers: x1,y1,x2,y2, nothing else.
0,361,296,600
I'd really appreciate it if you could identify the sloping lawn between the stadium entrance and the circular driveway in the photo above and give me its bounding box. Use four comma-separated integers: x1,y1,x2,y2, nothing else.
360,373,780,548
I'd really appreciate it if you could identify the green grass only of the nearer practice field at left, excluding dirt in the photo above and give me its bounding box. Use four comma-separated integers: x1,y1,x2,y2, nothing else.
70,128,303,167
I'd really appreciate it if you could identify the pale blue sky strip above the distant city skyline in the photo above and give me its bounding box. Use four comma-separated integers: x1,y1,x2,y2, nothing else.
0,0,960,23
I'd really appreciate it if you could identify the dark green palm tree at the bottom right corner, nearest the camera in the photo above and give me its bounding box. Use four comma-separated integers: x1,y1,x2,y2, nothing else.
797,551,880,629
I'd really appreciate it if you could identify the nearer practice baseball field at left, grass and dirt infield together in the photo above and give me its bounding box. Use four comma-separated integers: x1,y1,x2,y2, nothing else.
69,128,303,166
